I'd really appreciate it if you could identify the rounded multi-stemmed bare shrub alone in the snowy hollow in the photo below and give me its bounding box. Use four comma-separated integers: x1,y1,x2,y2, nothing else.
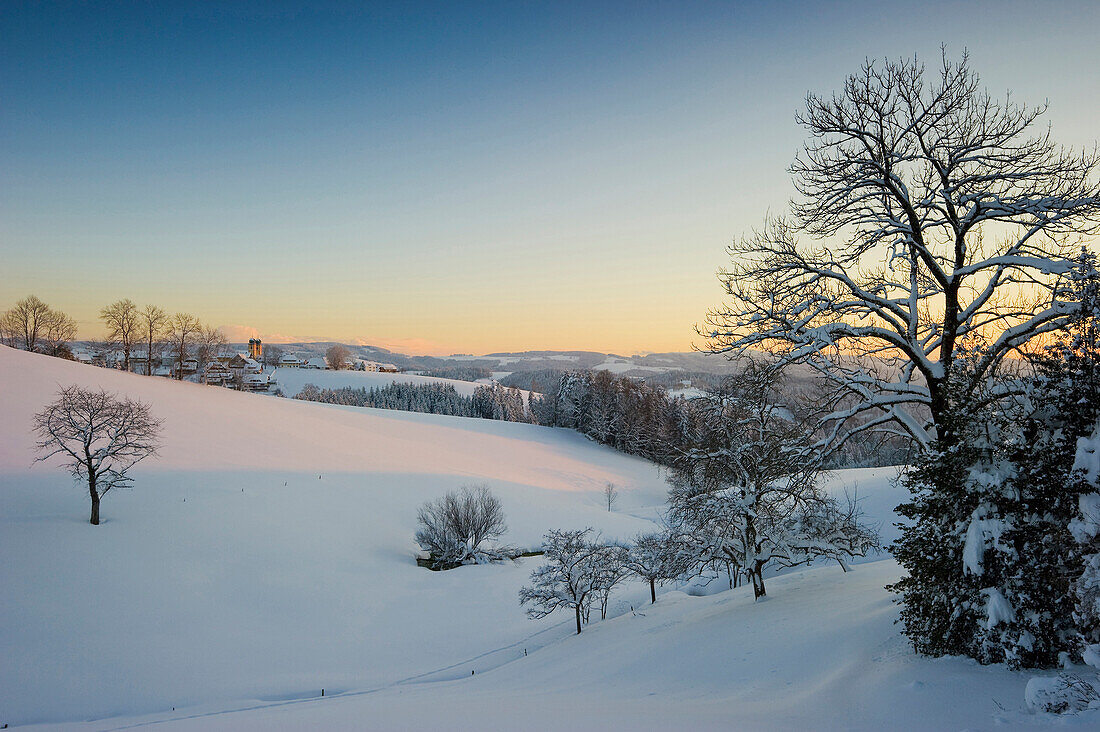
416,485,515,569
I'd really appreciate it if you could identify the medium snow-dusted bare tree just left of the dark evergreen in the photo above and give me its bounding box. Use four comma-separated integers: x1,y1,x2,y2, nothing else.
669,364,879,598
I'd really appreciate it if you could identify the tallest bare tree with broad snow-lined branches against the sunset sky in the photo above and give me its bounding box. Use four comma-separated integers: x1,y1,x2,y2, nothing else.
699,53,1100,446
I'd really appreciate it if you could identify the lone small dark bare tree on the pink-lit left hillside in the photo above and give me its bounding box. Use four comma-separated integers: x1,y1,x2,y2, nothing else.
34,386,161,525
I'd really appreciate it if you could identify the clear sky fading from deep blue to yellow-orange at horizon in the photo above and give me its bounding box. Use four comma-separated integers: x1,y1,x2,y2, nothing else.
0,0,1100,353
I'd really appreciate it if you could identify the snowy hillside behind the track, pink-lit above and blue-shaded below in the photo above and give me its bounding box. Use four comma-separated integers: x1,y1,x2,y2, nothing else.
0,347,664,723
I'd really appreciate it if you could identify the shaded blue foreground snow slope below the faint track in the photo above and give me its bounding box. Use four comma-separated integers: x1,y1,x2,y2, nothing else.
47,561,1060,731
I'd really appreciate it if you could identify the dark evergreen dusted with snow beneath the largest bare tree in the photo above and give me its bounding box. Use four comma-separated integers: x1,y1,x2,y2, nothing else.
891,253,1100,667
